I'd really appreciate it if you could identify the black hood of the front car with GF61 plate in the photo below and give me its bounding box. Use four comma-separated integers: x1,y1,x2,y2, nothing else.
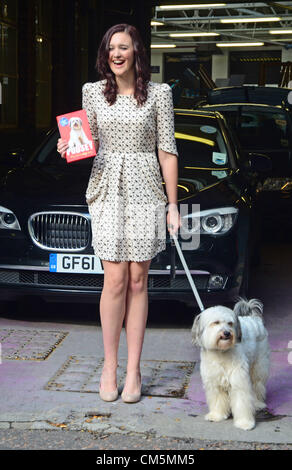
2,165,231,206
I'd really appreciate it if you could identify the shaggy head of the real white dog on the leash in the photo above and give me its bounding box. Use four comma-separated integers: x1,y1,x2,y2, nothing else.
192,306,241,351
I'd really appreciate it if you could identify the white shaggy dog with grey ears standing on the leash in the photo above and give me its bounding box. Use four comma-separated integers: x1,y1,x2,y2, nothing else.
192,299,269,430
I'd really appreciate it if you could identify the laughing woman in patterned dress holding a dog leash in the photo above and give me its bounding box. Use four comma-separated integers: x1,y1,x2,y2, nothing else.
58,24,181,403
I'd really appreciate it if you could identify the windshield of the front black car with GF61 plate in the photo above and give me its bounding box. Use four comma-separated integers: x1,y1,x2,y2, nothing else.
175,112,229,170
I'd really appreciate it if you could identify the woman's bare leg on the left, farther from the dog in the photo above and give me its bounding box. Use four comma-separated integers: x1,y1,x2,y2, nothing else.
100,261,129,392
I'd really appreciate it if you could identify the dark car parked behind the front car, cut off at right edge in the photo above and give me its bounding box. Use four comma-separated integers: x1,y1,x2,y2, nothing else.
198,86,292,230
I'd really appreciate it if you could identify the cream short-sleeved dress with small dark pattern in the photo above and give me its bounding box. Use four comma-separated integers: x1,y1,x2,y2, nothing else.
82,80,178,261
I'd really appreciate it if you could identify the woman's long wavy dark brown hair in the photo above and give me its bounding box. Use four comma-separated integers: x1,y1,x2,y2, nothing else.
96,23,151,106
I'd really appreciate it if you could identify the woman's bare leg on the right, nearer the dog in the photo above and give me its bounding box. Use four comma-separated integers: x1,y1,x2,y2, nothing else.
124,260,151,394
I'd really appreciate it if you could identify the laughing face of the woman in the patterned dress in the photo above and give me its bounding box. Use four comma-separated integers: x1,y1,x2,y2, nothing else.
108,32,134,76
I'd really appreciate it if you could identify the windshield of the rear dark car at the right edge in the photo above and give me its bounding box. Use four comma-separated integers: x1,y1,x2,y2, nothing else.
217,107,290,150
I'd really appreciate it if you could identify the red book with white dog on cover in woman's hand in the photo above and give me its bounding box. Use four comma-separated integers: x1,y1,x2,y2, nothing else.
56,109,96,163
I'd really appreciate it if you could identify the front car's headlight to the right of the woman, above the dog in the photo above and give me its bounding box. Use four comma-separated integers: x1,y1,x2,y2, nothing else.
182,207,238,235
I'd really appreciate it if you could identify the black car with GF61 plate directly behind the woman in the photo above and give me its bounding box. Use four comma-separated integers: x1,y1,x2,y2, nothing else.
0,109,266,305
